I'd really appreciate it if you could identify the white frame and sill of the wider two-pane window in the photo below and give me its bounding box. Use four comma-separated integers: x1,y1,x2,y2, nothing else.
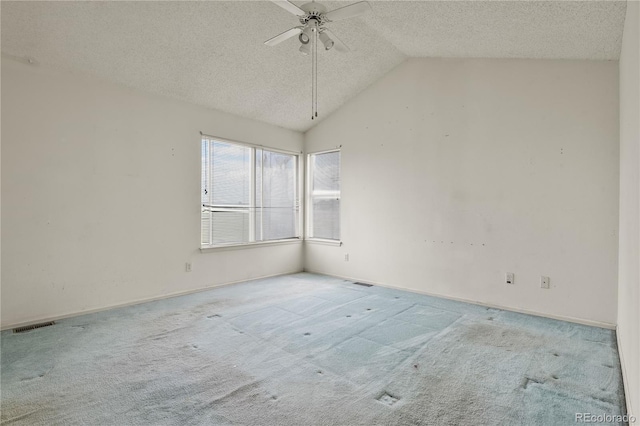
198,132,304,252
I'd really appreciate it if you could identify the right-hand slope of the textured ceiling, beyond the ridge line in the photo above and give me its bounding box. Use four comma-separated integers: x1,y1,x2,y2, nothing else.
366,1,626,60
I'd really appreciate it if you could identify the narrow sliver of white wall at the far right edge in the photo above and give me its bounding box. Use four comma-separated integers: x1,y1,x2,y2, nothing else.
618,1,640,416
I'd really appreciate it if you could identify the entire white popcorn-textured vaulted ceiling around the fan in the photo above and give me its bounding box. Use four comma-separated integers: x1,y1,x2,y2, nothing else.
0,1,626,131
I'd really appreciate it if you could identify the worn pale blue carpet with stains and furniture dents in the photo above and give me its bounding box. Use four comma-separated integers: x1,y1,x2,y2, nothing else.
1,274,624,426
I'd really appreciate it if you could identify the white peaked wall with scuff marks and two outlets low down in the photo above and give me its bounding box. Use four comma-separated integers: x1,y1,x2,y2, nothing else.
305,59,619,324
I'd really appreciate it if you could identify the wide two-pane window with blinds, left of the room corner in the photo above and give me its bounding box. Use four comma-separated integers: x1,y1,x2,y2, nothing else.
201,137,300,247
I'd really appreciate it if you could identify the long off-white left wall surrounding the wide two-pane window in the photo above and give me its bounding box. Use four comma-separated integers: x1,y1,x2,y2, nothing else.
2,58,303,328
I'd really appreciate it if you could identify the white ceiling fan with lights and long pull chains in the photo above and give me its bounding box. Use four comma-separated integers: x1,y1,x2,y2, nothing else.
264,0,371,120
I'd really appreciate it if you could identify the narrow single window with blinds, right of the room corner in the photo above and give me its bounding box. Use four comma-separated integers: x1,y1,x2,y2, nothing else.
307,151,340,240
